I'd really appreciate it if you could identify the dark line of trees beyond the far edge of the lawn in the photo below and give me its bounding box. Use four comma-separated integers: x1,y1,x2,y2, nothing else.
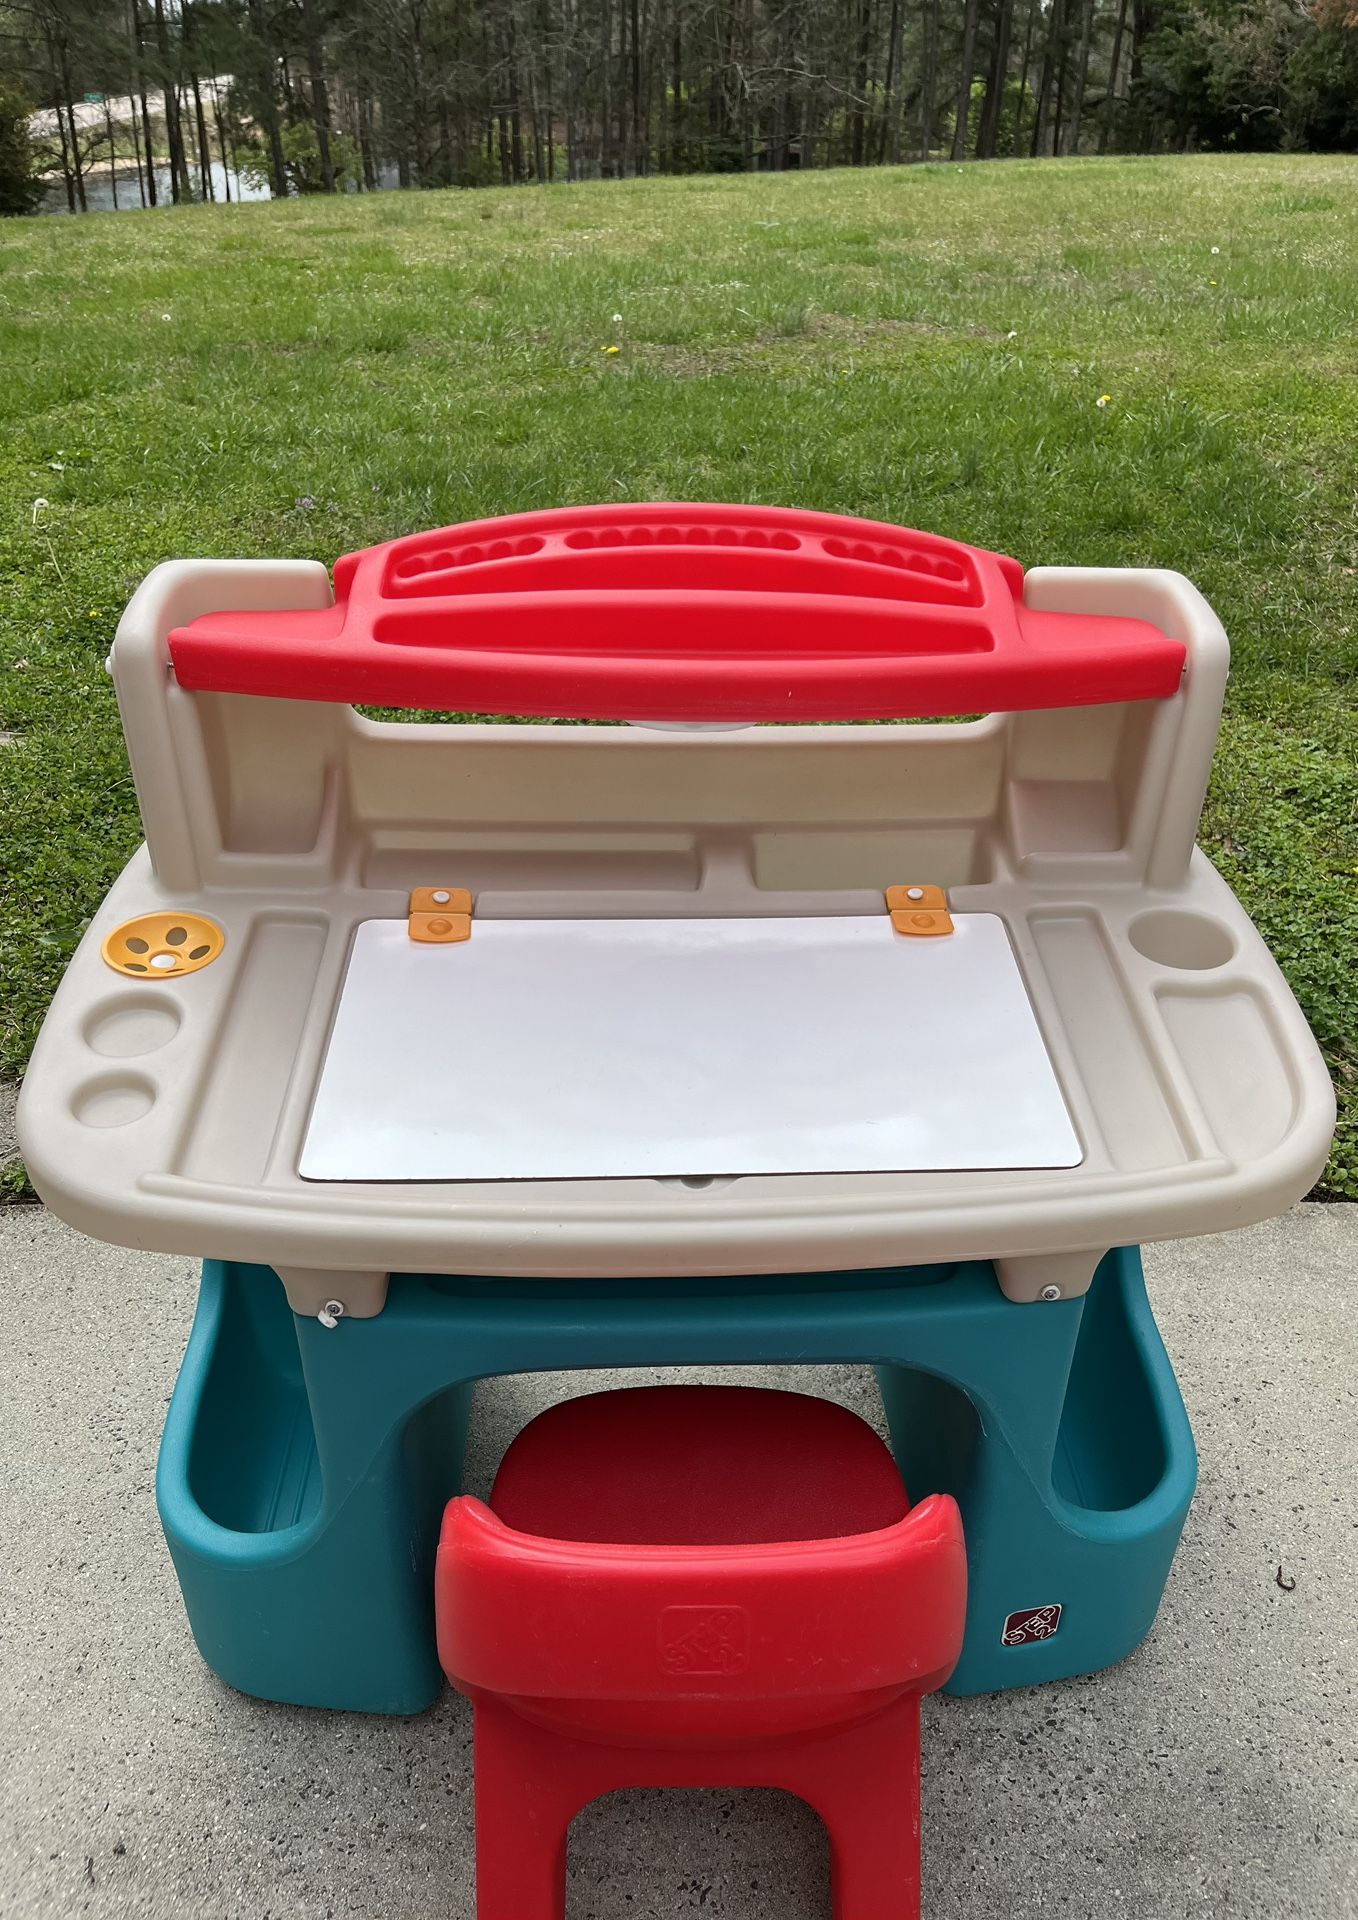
0,0,1358,211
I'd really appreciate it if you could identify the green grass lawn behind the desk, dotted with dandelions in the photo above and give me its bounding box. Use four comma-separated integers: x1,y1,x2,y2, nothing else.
0,157,1358,1198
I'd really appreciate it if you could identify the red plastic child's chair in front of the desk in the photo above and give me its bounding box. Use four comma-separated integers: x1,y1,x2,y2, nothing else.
436,1386,966,1920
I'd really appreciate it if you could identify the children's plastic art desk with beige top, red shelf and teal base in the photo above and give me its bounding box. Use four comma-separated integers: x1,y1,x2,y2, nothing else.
19,505,1333,1711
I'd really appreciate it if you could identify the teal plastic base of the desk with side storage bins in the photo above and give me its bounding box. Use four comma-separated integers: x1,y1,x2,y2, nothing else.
158,1248,1197,1713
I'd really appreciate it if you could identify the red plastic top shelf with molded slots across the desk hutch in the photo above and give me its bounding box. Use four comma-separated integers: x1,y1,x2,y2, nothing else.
169,505,1185,720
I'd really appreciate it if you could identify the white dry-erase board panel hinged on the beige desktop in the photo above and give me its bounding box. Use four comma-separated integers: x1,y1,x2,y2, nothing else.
300,914,1081,1181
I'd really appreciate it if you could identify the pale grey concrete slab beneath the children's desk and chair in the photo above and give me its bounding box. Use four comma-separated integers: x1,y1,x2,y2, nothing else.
0,1206,1358,1920
